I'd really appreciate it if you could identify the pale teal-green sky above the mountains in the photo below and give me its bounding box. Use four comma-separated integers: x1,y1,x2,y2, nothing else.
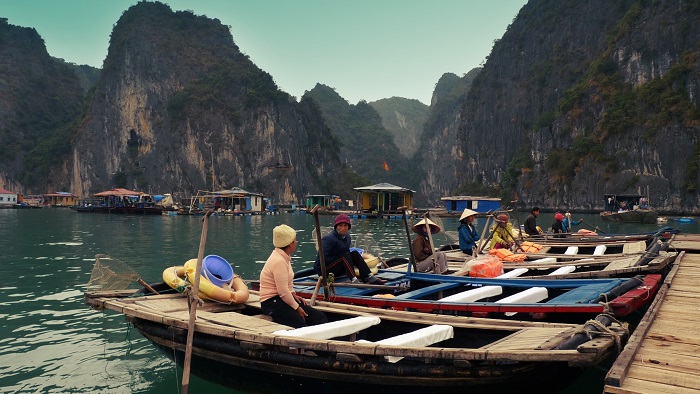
0,0,527,105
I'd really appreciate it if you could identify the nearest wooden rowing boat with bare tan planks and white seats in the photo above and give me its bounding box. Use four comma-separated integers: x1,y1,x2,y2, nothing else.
85,284,628,393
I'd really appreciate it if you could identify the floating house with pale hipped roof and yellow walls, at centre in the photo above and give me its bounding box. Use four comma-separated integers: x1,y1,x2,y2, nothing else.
353,183,415,215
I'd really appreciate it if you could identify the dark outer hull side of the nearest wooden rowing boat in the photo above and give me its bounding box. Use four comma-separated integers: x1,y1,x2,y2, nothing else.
132,318,578,394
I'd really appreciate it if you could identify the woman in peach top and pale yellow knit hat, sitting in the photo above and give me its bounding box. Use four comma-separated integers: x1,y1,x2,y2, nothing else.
260,224,328,328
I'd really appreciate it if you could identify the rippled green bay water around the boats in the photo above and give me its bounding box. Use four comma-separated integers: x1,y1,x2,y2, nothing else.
0,208,688,393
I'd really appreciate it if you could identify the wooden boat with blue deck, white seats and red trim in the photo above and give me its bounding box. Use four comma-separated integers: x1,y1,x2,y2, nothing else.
286,270,663,322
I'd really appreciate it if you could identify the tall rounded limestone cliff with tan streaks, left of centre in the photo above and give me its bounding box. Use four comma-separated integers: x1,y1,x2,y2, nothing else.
69,2,340,203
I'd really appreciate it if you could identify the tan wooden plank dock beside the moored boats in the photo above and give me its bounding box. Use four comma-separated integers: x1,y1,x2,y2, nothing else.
604,234,700,393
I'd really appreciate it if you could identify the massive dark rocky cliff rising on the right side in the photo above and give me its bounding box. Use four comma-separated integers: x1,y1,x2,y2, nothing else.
425,0,700,212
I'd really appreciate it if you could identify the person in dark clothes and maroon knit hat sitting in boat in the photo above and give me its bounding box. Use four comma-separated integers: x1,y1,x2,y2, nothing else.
314,213,386,285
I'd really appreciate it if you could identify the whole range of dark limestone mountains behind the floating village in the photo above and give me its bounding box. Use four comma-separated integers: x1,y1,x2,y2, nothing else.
0,0,700,214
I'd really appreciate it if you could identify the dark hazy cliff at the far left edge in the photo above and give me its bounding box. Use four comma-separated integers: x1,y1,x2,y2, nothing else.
0,18,83,194
